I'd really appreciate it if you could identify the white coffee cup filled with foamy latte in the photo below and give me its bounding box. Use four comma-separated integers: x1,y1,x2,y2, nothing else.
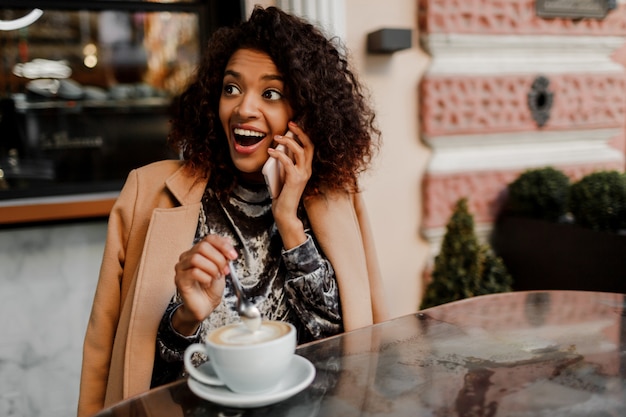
184,320,296,394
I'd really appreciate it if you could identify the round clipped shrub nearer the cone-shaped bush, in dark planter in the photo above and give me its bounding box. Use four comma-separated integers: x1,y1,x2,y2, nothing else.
504,167,570,222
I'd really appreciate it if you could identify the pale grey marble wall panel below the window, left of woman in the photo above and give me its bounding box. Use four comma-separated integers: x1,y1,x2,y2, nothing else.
0,220,106,417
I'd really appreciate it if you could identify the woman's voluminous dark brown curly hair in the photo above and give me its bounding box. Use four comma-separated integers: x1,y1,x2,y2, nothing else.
168,6,380,197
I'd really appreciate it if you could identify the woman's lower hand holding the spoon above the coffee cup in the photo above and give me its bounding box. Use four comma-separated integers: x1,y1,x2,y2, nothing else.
172,235,237,335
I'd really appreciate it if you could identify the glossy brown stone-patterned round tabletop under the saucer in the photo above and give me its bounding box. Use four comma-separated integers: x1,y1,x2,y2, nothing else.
92,291,626,417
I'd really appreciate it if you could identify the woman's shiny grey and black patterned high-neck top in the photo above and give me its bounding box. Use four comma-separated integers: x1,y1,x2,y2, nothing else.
152,180,343,387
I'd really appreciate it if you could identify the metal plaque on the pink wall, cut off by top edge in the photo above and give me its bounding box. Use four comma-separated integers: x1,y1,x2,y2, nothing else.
535,0,617,19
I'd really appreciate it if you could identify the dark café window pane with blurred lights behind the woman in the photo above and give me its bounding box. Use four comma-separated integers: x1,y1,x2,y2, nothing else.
0,9,201,200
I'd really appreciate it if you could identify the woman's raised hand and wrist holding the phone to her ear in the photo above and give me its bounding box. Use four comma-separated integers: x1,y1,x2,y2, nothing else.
269,118,315,250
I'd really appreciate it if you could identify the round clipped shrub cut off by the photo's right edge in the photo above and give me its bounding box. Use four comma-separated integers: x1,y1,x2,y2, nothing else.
569,171,626,232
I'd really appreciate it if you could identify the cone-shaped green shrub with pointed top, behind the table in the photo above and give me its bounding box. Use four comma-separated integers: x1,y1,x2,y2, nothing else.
420,198,512,309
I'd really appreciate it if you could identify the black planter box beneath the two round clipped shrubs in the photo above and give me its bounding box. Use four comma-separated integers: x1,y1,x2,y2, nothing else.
491,216,626,293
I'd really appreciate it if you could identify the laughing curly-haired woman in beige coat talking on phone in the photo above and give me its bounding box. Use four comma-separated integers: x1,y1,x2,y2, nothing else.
79,8,386,415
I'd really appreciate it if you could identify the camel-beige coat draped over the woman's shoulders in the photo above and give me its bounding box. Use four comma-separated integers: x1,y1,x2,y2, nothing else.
78,161,387,416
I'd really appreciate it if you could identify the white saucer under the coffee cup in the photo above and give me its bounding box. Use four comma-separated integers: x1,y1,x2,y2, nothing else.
187,355,315,408
